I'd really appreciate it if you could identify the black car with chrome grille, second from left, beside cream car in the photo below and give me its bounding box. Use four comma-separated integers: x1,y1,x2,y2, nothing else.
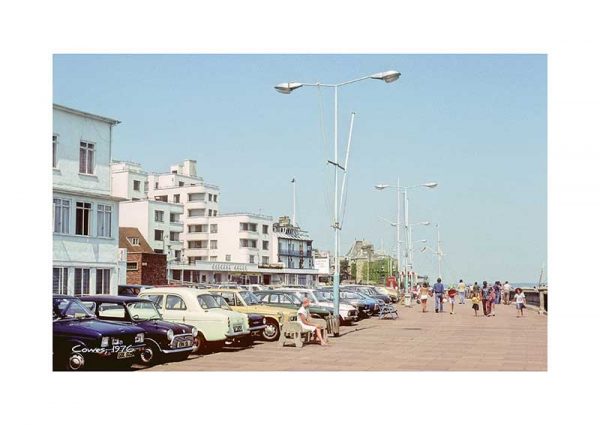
80,295,199,365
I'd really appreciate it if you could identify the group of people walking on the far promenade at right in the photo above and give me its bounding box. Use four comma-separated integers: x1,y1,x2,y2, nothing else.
413,278,525,317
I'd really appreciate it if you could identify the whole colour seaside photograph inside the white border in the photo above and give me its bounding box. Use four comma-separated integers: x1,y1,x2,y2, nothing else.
48,53,549,372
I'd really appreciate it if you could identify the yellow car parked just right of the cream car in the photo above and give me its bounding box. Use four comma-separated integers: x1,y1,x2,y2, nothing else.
209,289,297,341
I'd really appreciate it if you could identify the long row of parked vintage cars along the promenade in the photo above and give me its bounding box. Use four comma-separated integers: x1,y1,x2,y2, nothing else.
52,284,397,371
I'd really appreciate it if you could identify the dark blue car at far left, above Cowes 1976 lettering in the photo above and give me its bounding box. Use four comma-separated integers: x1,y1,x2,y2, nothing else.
52,295,146,370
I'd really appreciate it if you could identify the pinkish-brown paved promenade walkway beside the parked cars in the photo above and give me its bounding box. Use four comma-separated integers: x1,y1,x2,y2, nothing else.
145,301,548,371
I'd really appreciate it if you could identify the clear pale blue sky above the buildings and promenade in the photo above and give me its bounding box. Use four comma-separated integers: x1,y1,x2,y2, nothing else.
53,54,547,282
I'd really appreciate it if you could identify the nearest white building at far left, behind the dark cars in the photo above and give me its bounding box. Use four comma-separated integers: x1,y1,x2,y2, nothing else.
52,104,126,295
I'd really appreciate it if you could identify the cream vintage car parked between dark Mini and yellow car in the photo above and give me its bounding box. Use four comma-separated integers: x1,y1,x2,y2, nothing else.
139,286,250,347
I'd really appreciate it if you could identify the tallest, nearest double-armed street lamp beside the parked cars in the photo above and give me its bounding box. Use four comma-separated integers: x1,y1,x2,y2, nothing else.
274,70,400,317
